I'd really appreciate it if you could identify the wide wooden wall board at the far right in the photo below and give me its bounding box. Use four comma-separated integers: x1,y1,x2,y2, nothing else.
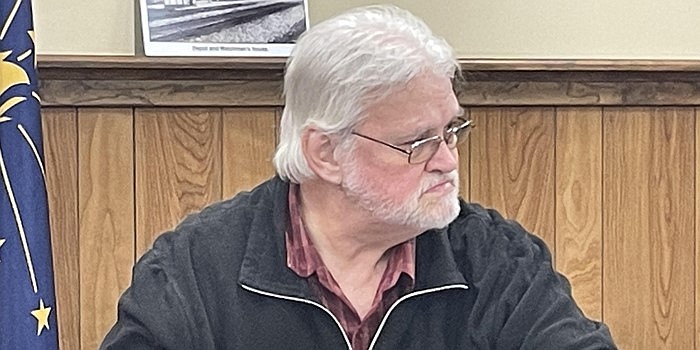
603,107,695,349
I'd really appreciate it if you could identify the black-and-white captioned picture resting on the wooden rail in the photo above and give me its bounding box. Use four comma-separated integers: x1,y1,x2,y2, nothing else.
139,0,309,57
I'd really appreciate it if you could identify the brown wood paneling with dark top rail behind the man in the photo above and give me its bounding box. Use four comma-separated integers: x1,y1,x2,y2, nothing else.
39,58,700,350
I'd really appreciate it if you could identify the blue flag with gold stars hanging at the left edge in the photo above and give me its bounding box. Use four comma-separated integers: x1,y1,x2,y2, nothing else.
0,0,58,350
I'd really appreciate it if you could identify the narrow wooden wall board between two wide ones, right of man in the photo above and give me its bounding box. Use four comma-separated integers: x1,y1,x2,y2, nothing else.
555,108,603,320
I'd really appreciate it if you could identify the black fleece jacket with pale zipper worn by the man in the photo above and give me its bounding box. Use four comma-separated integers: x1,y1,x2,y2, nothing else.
101,178,616,350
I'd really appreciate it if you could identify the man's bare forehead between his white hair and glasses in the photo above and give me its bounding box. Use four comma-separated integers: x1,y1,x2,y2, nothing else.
364,75,461,132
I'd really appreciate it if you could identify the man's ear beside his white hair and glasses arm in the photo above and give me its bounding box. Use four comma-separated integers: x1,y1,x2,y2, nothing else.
301,125,342,185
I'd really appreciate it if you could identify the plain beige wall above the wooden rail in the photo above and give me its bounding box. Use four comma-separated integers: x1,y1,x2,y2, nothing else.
34,0,700,59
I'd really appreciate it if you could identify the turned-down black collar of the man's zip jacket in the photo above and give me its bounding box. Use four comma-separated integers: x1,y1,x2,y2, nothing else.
239,177,466,301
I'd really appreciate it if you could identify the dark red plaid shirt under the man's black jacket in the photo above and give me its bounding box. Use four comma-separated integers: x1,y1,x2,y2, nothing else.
286,184,415,350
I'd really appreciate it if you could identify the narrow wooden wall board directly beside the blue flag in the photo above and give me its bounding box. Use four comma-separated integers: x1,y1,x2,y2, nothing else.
41,108,80,350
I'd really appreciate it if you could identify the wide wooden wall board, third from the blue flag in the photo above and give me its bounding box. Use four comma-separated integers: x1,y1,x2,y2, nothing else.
135,108,221,257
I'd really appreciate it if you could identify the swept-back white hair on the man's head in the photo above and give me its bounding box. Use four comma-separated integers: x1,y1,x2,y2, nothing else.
274,5,459,183
